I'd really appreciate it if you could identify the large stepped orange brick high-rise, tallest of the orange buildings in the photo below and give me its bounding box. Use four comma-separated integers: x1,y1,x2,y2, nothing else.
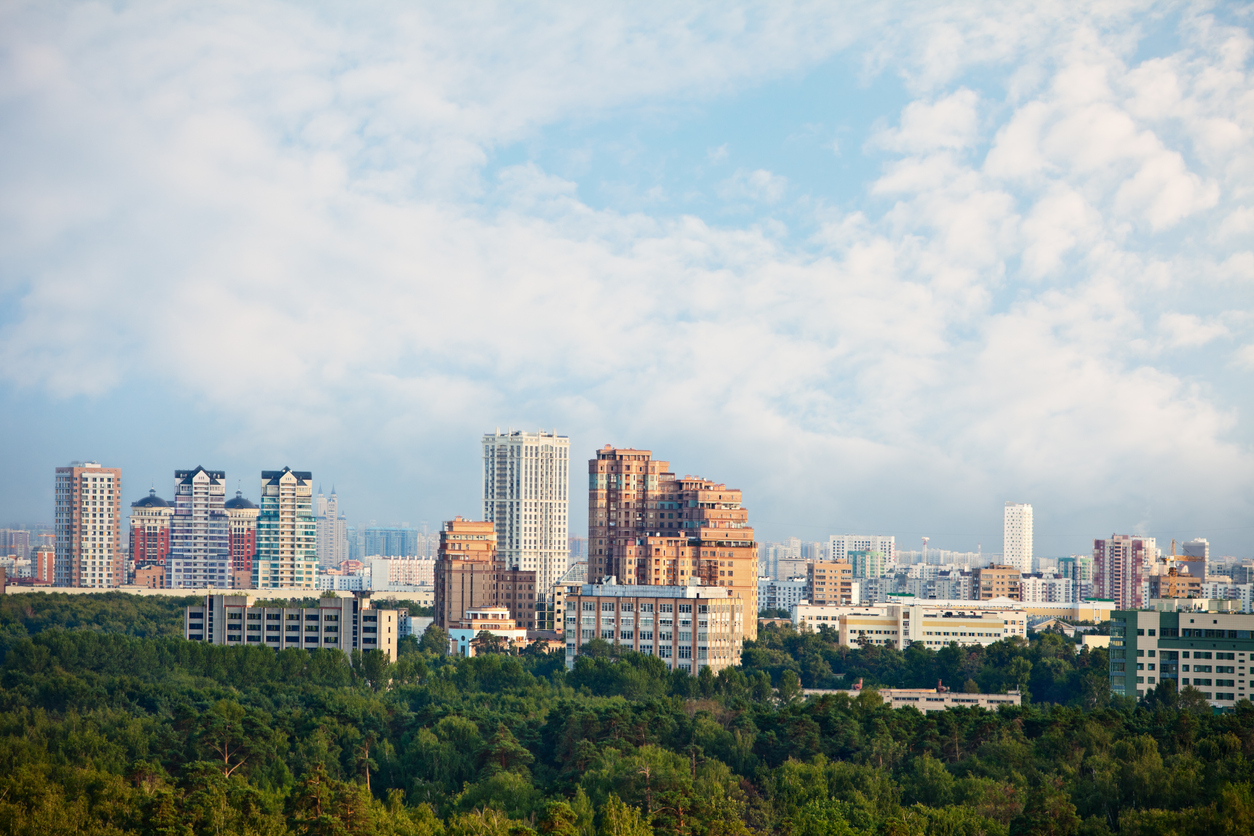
588,445,757,639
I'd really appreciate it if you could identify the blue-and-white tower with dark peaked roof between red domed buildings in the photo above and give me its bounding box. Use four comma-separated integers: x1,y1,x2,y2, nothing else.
166,468,231,589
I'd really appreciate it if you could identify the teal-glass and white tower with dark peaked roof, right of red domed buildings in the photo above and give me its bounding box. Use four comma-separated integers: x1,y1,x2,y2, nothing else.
252,468,317,589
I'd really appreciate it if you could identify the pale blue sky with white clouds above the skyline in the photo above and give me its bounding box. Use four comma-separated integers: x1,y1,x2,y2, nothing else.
0,0,1254,558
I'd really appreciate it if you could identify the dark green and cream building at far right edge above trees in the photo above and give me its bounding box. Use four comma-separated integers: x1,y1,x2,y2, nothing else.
1110,609,1254,709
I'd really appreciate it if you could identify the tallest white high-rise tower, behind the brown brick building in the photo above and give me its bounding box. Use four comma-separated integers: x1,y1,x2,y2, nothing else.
483,430,571,629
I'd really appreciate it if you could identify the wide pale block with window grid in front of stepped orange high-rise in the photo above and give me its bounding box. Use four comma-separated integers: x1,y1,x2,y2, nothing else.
566,583,742,674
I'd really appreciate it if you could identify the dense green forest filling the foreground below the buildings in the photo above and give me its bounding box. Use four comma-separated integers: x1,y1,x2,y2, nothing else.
0,593,1254,836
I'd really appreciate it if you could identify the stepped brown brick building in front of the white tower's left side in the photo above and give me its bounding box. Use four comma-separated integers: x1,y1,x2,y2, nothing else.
435,516,538,629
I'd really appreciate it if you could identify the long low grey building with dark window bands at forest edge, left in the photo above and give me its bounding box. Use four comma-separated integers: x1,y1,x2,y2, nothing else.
183,595,399,662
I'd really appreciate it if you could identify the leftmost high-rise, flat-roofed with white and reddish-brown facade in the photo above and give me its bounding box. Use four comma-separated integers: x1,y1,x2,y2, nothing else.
55,461,125,588
